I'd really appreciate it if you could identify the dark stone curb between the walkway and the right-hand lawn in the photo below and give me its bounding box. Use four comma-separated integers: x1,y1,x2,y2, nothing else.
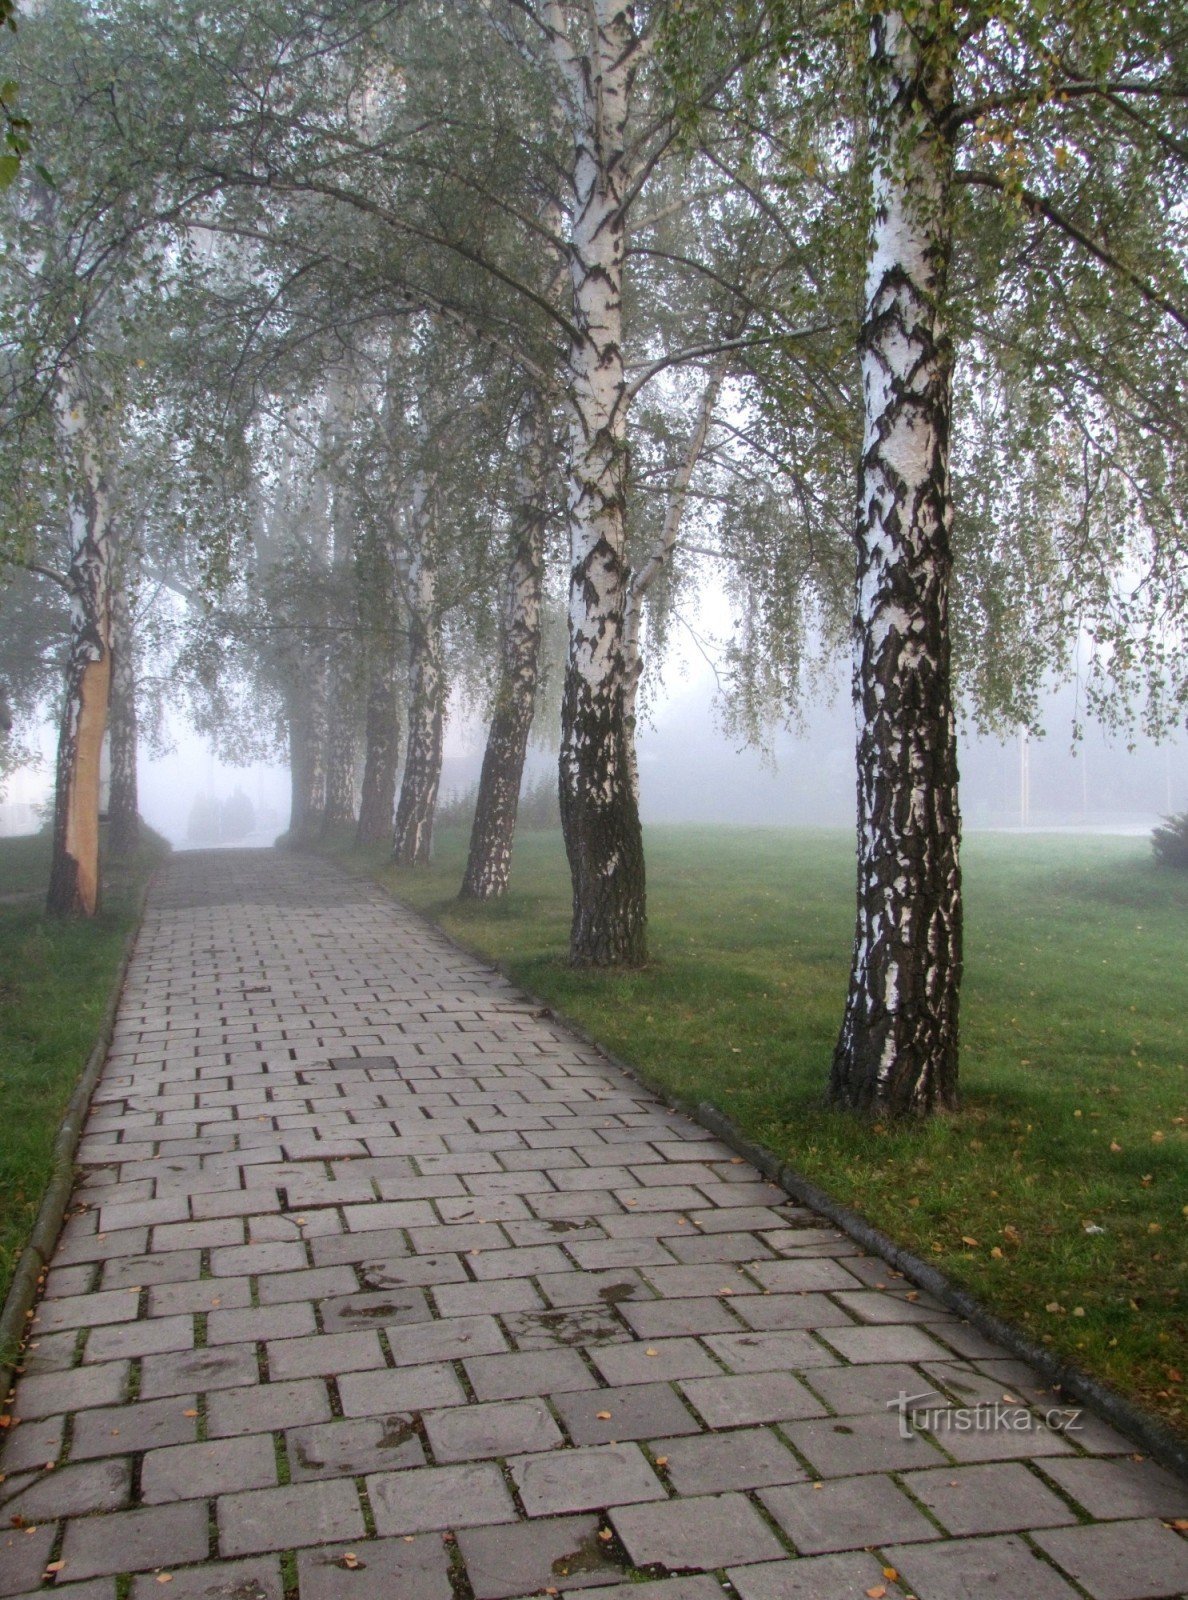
353,856,1188,1480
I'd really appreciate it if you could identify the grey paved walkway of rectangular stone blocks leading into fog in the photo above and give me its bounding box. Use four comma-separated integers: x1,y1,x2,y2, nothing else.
0,851,1188,1600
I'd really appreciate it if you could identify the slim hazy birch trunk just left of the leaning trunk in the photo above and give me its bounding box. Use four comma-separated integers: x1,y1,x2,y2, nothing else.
392,472,445,867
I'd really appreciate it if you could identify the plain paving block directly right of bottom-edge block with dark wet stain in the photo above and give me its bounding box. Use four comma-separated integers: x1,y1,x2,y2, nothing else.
610,1494,785,1571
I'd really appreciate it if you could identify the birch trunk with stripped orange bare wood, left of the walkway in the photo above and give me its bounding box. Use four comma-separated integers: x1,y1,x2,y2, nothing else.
46,371,114,917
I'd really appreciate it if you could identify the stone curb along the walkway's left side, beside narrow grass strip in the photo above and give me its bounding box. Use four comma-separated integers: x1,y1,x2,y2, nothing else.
0,867,160,1373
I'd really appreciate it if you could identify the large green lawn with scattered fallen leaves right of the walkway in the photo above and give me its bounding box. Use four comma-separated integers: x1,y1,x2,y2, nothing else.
328,827,1188,1432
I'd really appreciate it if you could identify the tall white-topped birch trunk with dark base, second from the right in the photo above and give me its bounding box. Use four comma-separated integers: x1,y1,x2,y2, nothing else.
548,0,647,966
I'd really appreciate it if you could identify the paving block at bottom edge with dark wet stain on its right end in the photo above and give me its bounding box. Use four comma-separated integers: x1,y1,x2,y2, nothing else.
458,1517,621,1600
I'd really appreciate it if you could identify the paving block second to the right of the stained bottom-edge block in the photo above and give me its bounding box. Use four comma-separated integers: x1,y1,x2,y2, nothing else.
759,1475,941,1555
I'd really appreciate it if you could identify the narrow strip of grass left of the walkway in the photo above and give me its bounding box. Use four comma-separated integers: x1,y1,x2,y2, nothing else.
0,834,163,1301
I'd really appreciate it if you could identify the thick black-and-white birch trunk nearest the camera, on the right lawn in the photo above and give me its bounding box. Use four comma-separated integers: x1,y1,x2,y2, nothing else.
831,6,962,1115
